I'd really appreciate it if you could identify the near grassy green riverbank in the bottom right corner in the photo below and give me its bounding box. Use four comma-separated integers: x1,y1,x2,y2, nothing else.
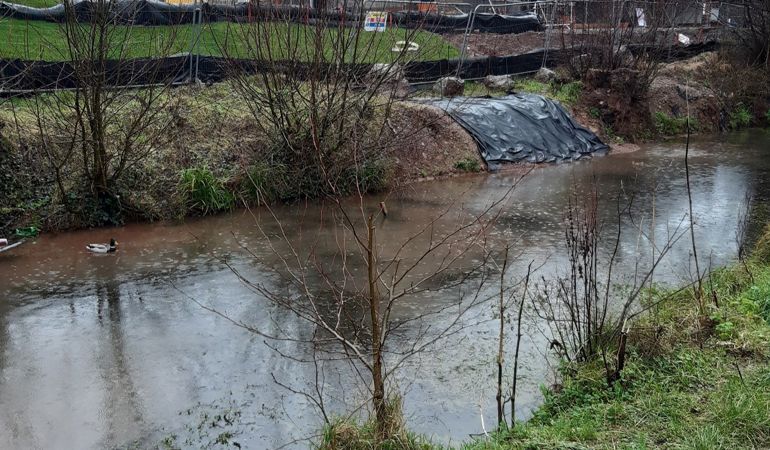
321,231,770,450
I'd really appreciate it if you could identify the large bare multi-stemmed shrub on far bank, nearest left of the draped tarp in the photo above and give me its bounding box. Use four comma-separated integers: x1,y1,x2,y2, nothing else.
219,2,452,198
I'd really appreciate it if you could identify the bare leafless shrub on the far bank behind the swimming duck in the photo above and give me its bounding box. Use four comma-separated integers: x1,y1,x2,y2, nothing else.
7,0,183,226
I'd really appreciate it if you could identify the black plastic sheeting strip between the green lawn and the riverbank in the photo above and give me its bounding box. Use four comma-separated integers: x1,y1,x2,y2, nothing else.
0,51,558,94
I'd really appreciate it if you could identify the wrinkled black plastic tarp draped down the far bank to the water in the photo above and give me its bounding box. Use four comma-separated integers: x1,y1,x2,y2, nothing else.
425,94,609,170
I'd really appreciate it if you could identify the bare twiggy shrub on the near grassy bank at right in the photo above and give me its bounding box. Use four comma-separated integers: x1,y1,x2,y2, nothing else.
534,182,685,385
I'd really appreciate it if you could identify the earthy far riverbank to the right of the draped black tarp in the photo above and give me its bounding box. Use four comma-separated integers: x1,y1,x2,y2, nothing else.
471,49,770,145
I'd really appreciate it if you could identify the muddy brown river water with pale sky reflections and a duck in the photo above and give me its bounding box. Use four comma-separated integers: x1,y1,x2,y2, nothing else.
0,130,770,449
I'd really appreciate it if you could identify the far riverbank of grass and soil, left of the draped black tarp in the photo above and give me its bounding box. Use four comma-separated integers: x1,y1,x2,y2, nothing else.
0,83,485,239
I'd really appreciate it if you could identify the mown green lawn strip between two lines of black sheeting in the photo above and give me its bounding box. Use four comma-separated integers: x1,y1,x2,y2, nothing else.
0,18,458,62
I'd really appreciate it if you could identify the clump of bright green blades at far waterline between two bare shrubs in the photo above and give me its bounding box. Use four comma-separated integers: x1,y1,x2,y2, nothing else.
180,167,235,215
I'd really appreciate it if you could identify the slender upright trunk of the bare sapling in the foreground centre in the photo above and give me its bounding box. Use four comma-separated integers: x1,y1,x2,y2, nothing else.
366,215,388,439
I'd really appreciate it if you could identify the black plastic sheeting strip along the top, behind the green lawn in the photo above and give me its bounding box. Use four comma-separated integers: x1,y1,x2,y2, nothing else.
0,0,542,34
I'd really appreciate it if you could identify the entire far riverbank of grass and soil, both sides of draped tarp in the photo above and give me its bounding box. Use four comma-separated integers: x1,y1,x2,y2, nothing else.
0,48,770,236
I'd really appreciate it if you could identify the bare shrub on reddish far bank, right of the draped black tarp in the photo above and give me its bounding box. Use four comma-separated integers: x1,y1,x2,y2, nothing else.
560,0,692,139
